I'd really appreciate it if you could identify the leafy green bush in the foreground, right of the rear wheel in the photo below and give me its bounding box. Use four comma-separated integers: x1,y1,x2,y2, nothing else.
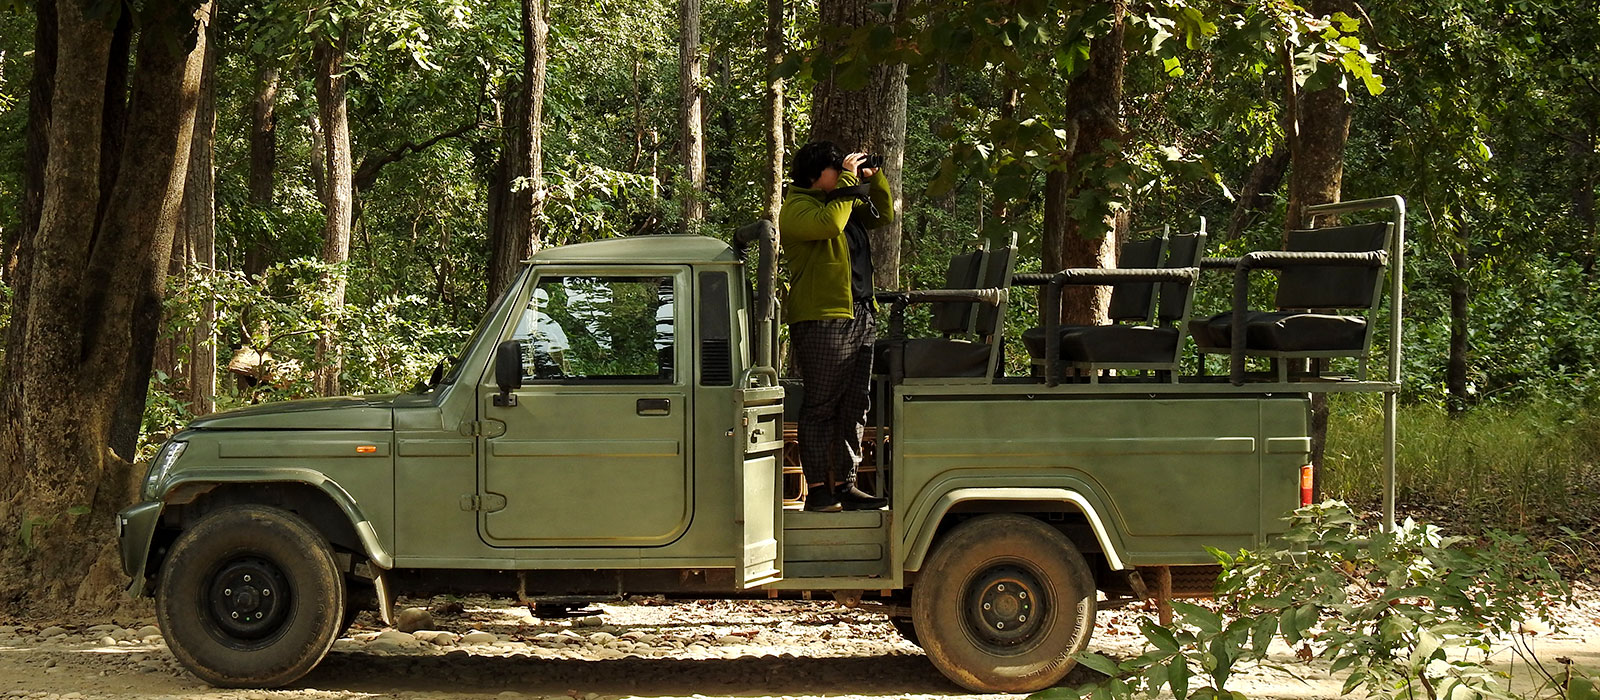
1035,502,1571,700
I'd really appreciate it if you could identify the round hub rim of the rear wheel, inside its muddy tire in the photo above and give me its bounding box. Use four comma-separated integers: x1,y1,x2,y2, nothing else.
962,561,1051,655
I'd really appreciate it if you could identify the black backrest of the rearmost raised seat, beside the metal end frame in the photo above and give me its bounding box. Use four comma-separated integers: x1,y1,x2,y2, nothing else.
1277,222,1392,308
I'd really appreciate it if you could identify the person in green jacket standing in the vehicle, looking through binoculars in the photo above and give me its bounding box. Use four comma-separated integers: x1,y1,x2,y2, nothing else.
778,141,894,511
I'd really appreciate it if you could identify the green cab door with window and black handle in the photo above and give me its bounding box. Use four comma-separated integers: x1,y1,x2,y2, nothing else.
478,265,693,547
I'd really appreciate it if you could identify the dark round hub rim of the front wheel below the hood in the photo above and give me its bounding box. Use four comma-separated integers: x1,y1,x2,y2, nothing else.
203,556,293,647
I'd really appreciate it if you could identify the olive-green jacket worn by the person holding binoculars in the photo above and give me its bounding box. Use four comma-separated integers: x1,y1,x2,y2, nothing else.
778,171,894,323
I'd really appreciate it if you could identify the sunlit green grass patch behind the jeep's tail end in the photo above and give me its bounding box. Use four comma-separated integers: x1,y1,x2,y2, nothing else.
1323,395,1600,529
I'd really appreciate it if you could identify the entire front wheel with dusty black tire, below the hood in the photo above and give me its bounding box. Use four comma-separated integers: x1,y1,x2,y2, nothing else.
155,505,344,687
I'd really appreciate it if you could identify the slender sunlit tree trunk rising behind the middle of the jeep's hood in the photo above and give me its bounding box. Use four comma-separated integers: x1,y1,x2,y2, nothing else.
312,34,355,396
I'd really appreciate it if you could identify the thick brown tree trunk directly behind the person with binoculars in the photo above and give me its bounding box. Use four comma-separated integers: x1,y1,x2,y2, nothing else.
811,0,906,289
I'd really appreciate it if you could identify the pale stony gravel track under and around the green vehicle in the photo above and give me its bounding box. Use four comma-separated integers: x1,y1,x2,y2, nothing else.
0,587,1600,700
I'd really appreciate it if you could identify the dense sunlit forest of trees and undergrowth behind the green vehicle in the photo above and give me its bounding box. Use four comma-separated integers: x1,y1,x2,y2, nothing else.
0,0,1600,607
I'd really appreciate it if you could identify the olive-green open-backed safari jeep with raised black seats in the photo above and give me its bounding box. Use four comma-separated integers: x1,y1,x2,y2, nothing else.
118,198,1403,692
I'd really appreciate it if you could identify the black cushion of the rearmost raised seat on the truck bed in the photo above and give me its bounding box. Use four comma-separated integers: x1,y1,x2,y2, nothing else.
1189,312,1366,352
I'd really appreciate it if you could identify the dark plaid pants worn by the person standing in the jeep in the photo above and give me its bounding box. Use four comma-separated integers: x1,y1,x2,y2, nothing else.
789,304,877,486
